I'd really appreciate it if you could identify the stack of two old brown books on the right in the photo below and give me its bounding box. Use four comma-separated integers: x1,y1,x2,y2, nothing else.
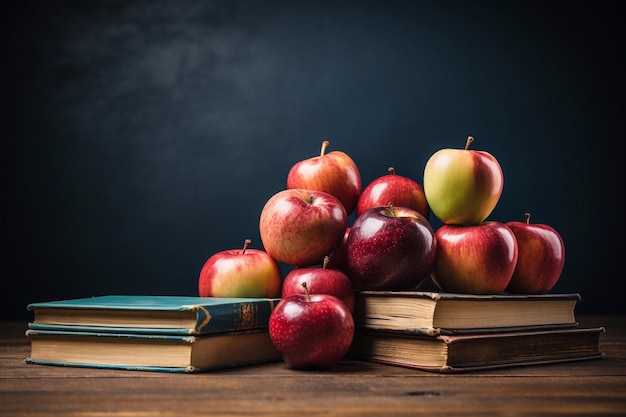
350,291,605,373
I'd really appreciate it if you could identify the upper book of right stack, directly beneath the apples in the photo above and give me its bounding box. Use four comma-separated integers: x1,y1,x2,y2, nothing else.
354,291,580,336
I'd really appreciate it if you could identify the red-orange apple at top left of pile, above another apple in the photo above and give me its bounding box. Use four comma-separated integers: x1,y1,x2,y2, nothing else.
287,140,361,215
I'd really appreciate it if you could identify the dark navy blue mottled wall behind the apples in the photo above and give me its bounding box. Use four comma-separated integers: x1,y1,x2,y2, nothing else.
0,0,626,319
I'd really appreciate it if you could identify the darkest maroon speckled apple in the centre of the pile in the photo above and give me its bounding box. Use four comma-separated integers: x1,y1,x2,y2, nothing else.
346,204,437,290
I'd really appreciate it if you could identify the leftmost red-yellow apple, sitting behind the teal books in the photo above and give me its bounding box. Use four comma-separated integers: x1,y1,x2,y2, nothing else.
198,239,282,298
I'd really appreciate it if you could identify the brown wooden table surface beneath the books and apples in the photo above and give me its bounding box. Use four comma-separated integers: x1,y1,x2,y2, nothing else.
0,316,626,417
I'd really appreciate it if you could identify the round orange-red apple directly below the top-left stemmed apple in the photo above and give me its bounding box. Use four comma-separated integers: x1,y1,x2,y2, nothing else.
259,188,348,266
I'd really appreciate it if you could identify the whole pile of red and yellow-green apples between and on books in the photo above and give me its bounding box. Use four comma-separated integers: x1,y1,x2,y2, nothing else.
198,137,565,369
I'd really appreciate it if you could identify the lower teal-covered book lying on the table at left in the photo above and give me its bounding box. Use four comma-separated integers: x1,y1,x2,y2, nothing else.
25,329,281,373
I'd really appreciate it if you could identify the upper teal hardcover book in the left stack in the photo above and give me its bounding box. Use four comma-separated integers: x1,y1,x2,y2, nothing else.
27,295,280,335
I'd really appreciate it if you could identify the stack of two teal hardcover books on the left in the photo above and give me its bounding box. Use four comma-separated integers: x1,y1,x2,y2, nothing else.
26,295,281,373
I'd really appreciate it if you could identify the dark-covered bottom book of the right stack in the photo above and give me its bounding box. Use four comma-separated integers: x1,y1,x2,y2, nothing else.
350,327,605,373
